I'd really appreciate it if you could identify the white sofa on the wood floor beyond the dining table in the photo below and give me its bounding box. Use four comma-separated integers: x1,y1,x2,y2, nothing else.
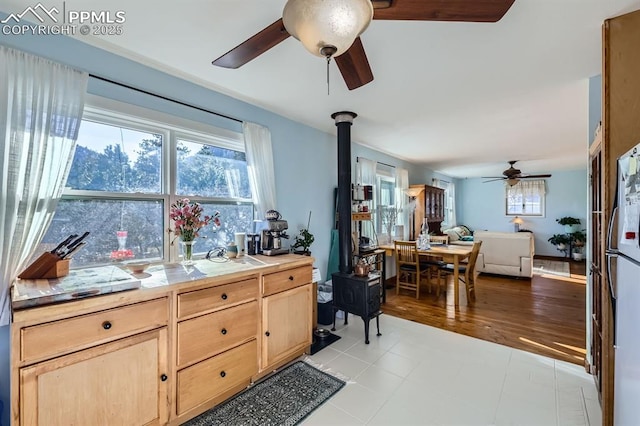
473,231,535,278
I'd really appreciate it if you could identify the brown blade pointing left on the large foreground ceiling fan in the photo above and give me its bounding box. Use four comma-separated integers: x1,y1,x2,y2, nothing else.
211,19,289,68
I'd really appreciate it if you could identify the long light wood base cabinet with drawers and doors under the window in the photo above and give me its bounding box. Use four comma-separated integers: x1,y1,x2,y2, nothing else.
11,255,313,425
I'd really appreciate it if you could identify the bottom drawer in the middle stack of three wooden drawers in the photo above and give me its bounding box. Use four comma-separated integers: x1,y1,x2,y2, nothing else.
177,340,258,415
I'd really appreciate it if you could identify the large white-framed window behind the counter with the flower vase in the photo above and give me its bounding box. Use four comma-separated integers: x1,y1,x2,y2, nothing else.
42,101,253,267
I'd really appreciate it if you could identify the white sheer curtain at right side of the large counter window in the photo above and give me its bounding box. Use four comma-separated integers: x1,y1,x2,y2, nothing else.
242,122,277,219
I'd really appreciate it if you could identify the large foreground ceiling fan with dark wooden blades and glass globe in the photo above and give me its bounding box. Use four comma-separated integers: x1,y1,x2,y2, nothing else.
212,0,515,90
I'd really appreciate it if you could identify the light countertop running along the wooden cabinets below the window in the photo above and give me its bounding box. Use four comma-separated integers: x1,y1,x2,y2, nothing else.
11,254,313,310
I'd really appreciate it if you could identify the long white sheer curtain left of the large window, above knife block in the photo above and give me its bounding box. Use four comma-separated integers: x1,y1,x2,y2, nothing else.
0,46,88,325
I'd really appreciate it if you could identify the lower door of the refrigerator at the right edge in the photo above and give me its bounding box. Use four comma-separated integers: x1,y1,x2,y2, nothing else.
613,256,640,426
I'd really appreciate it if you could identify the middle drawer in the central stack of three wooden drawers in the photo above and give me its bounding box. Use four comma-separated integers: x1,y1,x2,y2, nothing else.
178,301,258,366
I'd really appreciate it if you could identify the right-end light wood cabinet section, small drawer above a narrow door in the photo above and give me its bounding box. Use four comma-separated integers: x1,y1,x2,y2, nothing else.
260,266,313,372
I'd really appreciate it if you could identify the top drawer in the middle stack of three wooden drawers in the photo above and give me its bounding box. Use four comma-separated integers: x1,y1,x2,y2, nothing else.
178,278,258,318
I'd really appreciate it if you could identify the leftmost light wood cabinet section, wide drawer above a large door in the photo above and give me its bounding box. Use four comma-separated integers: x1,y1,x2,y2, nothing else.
18,298,169,425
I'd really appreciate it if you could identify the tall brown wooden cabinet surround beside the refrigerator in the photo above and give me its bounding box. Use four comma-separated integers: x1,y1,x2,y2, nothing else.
591,11,640,425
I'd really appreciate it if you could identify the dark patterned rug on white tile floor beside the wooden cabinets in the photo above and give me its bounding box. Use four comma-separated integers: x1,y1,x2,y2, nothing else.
184,361,345,426
